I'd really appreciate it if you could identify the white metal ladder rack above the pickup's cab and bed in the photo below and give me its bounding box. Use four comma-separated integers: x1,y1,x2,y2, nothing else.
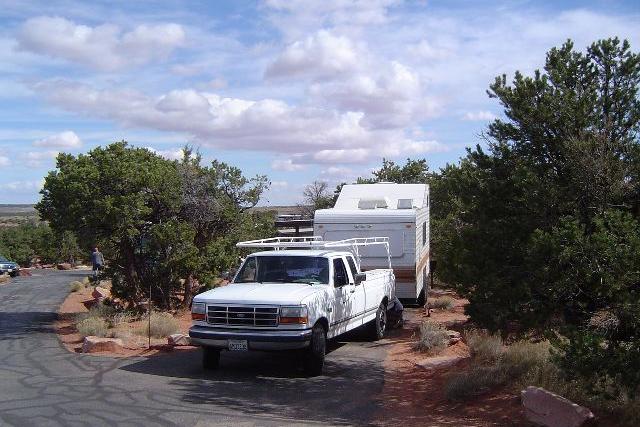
236,236,391,268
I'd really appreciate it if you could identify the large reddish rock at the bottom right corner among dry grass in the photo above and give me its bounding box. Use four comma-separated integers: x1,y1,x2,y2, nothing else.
520,386,594,427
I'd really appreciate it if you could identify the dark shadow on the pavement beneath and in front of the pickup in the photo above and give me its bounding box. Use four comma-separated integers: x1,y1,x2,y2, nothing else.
120,343,384,425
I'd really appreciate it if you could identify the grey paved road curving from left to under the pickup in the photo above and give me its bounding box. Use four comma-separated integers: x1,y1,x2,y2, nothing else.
0,271,385,426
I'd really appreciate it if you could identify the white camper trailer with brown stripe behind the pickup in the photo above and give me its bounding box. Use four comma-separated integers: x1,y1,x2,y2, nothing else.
313,183,429,305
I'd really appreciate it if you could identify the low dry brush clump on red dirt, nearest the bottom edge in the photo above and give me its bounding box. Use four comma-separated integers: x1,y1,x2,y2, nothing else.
444,365,505,400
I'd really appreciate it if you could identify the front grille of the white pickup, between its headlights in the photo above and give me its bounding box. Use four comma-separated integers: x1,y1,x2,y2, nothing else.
207,305,278,326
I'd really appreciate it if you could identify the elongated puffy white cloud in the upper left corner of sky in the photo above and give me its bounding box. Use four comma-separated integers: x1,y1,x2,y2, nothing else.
18,16,185,71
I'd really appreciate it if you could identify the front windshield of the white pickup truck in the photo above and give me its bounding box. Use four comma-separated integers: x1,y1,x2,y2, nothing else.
234,255,329,285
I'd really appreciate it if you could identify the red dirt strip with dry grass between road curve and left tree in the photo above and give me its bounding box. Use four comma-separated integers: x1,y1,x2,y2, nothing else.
55,286,195,357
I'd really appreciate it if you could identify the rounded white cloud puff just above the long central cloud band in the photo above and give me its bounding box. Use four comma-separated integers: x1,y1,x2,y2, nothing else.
265,30,358,78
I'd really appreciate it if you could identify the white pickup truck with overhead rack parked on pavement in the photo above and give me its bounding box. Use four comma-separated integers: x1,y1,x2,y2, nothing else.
189,237,395,375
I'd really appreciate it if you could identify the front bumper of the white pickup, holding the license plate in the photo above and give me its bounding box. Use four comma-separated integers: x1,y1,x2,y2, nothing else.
189,326,311,351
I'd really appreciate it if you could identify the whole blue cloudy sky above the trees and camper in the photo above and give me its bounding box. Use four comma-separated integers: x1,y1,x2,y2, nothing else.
0,0,640,204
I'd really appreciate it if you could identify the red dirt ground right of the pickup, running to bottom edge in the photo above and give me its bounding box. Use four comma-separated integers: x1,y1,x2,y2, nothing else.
378,298,528,427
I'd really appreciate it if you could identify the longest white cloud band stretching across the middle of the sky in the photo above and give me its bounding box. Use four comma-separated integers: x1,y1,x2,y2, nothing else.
34,80,444,168
